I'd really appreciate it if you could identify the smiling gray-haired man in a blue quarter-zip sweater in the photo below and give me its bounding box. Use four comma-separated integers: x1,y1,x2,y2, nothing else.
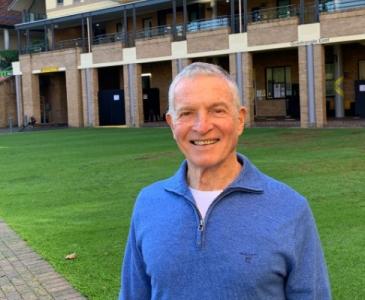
120,63,331,300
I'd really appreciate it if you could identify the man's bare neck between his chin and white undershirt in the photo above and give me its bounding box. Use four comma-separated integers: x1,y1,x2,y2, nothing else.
187,159,242,191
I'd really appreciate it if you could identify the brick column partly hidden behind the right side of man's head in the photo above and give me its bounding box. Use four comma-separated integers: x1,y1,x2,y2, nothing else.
229,52,255,127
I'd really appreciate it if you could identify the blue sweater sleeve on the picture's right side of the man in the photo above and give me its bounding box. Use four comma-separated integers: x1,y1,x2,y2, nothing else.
285,204,332,300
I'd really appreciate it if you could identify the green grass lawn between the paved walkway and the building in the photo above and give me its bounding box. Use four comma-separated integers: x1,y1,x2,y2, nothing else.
0,128,365,300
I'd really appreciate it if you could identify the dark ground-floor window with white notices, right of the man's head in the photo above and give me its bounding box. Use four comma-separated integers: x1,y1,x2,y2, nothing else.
266,67,292,99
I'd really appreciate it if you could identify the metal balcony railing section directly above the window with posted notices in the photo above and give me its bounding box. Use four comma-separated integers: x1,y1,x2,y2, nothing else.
248,4,299,23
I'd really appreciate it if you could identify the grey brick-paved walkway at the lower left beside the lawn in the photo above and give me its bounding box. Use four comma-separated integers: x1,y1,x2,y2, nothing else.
0,219,86,300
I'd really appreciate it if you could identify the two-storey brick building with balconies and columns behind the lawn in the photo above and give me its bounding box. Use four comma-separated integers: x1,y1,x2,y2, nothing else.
11,0,365,127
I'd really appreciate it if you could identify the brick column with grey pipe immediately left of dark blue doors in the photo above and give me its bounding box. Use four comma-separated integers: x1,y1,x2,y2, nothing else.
81,68,99,127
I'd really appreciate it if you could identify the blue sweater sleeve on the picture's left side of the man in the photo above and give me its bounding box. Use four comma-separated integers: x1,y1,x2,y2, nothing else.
119,214,151,300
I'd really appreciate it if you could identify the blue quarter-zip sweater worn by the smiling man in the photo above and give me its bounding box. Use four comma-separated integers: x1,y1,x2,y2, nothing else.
119,154,331,300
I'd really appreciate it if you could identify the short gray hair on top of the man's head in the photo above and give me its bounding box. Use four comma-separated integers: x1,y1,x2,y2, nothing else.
167,62,241,118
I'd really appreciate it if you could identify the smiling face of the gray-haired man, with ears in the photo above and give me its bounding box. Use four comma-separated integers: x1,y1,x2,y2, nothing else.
167,75,245,169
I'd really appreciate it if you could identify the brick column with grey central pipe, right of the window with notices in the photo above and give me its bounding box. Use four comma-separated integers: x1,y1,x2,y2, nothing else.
298,45,327,128
